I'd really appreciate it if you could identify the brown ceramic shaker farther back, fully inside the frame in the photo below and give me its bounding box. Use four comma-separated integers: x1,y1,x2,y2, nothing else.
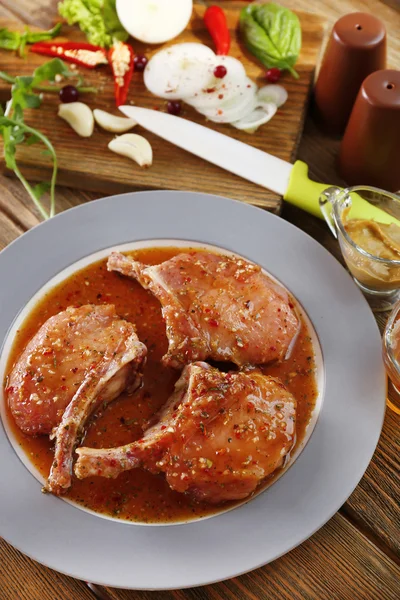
314,12,386,135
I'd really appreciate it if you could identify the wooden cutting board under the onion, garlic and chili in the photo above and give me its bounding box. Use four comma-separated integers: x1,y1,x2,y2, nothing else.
0,1,325,212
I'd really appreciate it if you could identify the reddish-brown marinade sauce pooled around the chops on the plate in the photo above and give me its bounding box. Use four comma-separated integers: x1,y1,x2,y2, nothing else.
3,248,317,522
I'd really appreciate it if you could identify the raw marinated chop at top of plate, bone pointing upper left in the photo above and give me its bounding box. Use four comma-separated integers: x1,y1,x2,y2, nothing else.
108,252,299,368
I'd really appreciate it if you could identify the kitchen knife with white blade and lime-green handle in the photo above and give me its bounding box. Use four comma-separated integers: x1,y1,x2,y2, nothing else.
120,106,393,223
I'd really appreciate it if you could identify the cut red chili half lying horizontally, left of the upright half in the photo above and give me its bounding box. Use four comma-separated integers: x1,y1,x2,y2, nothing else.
31,42,108,69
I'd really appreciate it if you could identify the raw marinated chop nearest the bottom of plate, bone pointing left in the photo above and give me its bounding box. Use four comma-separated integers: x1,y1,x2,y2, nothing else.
75,362,296,504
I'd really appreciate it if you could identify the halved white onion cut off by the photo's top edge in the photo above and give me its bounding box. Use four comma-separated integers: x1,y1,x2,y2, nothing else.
116,0,193,44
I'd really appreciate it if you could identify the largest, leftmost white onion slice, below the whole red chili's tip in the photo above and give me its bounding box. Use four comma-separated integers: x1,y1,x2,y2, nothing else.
144,43,215,100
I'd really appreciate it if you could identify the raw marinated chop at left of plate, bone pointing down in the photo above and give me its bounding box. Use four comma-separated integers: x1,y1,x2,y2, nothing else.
6,304,147,494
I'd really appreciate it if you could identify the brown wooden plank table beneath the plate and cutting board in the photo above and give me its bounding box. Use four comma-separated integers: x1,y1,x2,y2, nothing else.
0,0,400,600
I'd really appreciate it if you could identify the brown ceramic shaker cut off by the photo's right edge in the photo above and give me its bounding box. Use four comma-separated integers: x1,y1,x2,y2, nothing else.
338,69,400,192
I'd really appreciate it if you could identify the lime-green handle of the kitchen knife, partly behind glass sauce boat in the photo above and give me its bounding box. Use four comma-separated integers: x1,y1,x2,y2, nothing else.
283,160,400,224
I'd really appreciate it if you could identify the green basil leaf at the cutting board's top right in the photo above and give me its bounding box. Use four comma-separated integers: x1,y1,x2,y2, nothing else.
240,2,301,79
